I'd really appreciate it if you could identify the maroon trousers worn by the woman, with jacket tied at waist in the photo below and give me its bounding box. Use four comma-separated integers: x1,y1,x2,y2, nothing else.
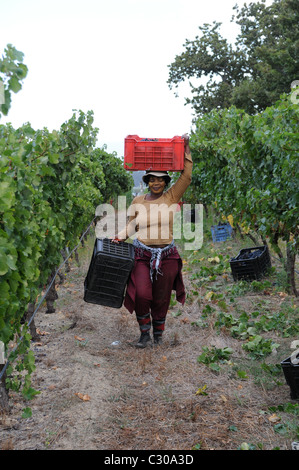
124,248,185,334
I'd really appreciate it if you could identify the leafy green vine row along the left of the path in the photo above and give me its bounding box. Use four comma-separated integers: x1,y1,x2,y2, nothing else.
0,106,130,398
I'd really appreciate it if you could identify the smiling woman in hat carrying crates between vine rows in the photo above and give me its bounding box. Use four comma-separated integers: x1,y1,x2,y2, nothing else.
113,135,193,348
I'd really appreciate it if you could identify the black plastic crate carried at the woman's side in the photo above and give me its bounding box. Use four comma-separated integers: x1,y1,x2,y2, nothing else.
84,238,134,308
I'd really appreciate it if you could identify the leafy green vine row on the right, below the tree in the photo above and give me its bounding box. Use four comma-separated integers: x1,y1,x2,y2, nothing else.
190,92,299,294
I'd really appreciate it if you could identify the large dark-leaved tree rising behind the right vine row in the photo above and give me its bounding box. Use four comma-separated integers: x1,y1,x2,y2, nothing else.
167,0,299,114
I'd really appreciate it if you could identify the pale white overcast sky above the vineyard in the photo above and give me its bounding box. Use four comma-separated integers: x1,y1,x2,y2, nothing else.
0,0,272,157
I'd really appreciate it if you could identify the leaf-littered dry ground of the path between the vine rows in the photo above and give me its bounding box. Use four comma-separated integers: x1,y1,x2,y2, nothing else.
0,215,299,450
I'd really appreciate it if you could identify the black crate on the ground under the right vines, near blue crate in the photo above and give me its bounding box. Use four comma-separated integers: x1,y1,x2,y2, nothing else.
230,245,271,281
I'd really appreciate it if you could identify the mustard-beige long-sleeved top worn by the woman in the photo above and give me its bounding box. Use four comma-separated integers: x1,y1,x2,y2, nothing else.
117,153,193,246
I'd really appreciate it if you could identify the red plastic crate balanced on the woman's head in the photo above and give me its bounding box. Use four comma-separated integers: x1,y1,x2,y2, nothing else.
124,135,184,171
